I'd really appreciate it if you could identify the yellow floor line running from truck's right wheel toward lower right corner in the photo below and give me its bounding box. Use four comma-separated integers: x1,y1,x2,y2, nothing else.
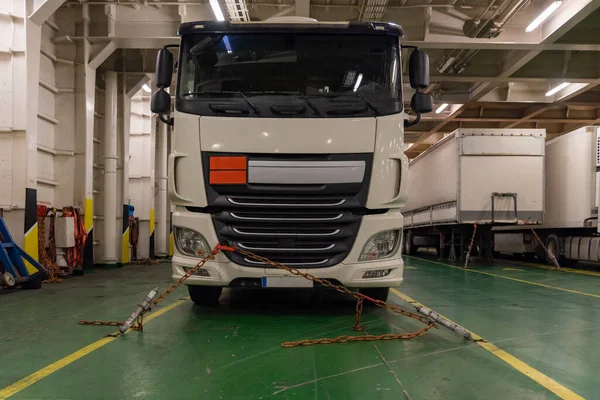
391,288,583,400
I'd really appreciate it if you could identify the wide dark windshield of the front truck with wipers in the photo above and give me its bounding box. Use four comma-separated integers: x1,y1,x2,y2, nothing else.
177,33,402,118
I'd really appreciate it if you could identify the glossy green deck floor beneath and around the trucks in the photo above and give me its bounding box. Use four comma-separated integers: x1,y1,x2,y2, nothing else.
0,258,600,400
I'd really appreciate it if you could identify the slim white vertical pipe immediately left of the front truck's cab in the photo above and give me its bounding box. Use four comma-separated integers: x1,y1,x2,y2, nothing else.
156,121,169,257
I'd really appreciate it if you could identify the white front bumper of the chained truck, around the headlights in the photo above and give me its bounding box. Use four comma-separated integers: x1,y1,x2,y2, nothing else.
172,209,404,288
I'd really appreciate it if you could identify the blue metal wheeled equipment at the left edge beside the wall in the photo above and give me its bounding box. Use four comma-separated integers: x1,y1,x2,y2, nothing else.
0,216,46,289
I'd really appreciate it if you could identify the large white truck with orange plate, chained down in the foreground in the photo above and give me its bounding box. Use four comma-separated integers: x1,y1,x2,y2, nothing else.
152,18,432,304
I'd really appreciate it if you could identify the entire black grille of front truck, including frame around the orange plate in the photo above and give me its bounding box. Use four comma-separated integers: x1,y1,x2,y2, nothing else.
202,152,370,268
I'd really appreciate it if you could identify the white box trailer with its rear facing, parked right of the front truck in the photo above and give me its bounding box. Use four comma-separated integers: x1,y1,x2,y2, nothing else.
401,129,546,260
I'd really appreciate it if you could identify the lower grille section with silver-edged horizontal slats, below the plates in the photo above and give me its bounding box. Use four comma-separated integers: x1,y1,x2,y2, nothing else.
213,199,361,268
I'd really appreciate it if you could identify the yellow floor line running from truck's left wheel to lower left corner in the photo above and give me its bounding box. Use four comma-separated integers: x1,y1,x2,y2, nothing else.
0,297,189,400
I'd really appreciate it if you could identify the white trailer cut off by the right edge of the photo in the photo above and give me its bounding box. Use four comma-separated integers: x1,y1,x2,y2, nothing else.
494,126,600,265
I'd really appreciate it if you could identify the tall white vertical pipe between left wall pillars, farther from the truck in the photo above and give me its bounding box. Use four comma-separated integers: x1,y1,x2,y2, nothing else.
102,71,119,264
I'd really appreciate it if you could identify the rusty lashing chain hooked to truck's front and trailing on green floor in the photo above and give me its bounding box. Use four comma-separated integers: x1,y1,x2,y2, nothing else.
79,245,437,347
